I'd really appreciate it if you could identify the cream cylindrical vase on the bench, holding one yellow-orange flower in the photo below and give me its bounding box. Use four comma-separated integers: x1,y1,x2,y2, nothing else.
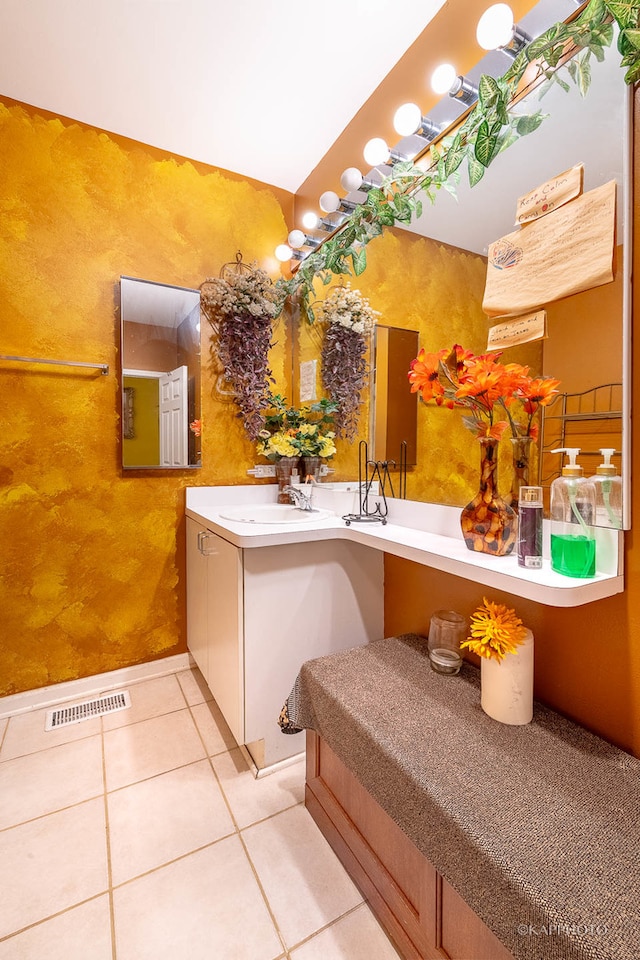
480,630,533,726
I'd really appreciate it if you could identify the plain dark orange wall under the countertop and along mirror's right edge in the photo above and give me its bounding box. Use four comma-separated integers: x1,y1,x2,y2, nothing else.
385,92,640,756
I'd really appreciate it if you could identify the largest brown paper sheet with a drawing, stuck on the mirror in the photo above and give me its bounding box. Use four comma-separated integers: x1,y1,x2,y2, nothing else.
482,180,616,317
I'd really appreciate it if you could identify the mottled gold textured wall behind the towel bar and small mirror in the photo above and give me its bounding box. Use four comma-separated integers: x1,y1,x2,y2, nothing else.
0,100,292,695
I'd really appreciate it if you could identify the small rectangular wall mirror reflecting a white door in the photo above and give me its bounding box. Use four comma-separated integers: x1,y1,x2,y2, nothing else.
120,277,201,470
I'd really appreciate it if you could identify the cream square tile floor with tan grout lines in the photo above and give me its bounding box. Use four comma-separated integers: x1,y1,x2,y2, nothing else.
0,670,398,960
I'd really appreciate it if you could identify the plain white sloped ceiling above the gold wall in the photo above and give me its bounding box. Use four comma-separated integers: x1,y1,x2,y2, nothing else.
0,0,444,193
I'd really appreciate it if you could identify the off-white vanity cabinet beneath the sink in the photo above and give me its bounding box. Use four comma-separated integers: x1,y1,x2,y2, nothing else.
186,517,383,770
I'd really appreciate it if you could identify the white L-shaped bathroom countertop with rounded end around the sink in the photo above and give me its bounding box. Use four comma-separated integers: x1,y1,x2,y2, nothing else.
186,484,624,607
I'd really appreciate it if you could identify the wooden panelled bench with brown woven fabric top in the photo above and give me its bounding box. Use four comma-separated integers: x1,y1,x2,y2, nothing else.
281,635,640,960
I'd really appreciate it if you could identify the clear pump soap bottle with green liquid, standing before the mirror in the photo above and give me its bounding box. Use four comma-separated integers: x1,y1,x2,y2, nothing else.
550,447,596,577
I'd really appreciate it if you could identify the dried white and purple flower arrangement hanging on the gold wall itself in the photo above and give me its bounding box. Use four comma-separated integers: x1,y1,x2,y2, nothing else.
200,252,283,440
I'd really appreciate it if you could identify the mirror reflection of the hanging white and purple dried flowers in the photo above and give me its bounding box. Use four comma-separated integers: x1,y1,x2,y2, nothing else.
320,283,380,440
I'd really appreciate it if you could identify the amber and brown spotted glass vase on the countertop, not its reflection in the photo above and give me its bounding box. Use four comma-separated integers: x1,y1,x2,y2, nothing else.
460,437,517,557
